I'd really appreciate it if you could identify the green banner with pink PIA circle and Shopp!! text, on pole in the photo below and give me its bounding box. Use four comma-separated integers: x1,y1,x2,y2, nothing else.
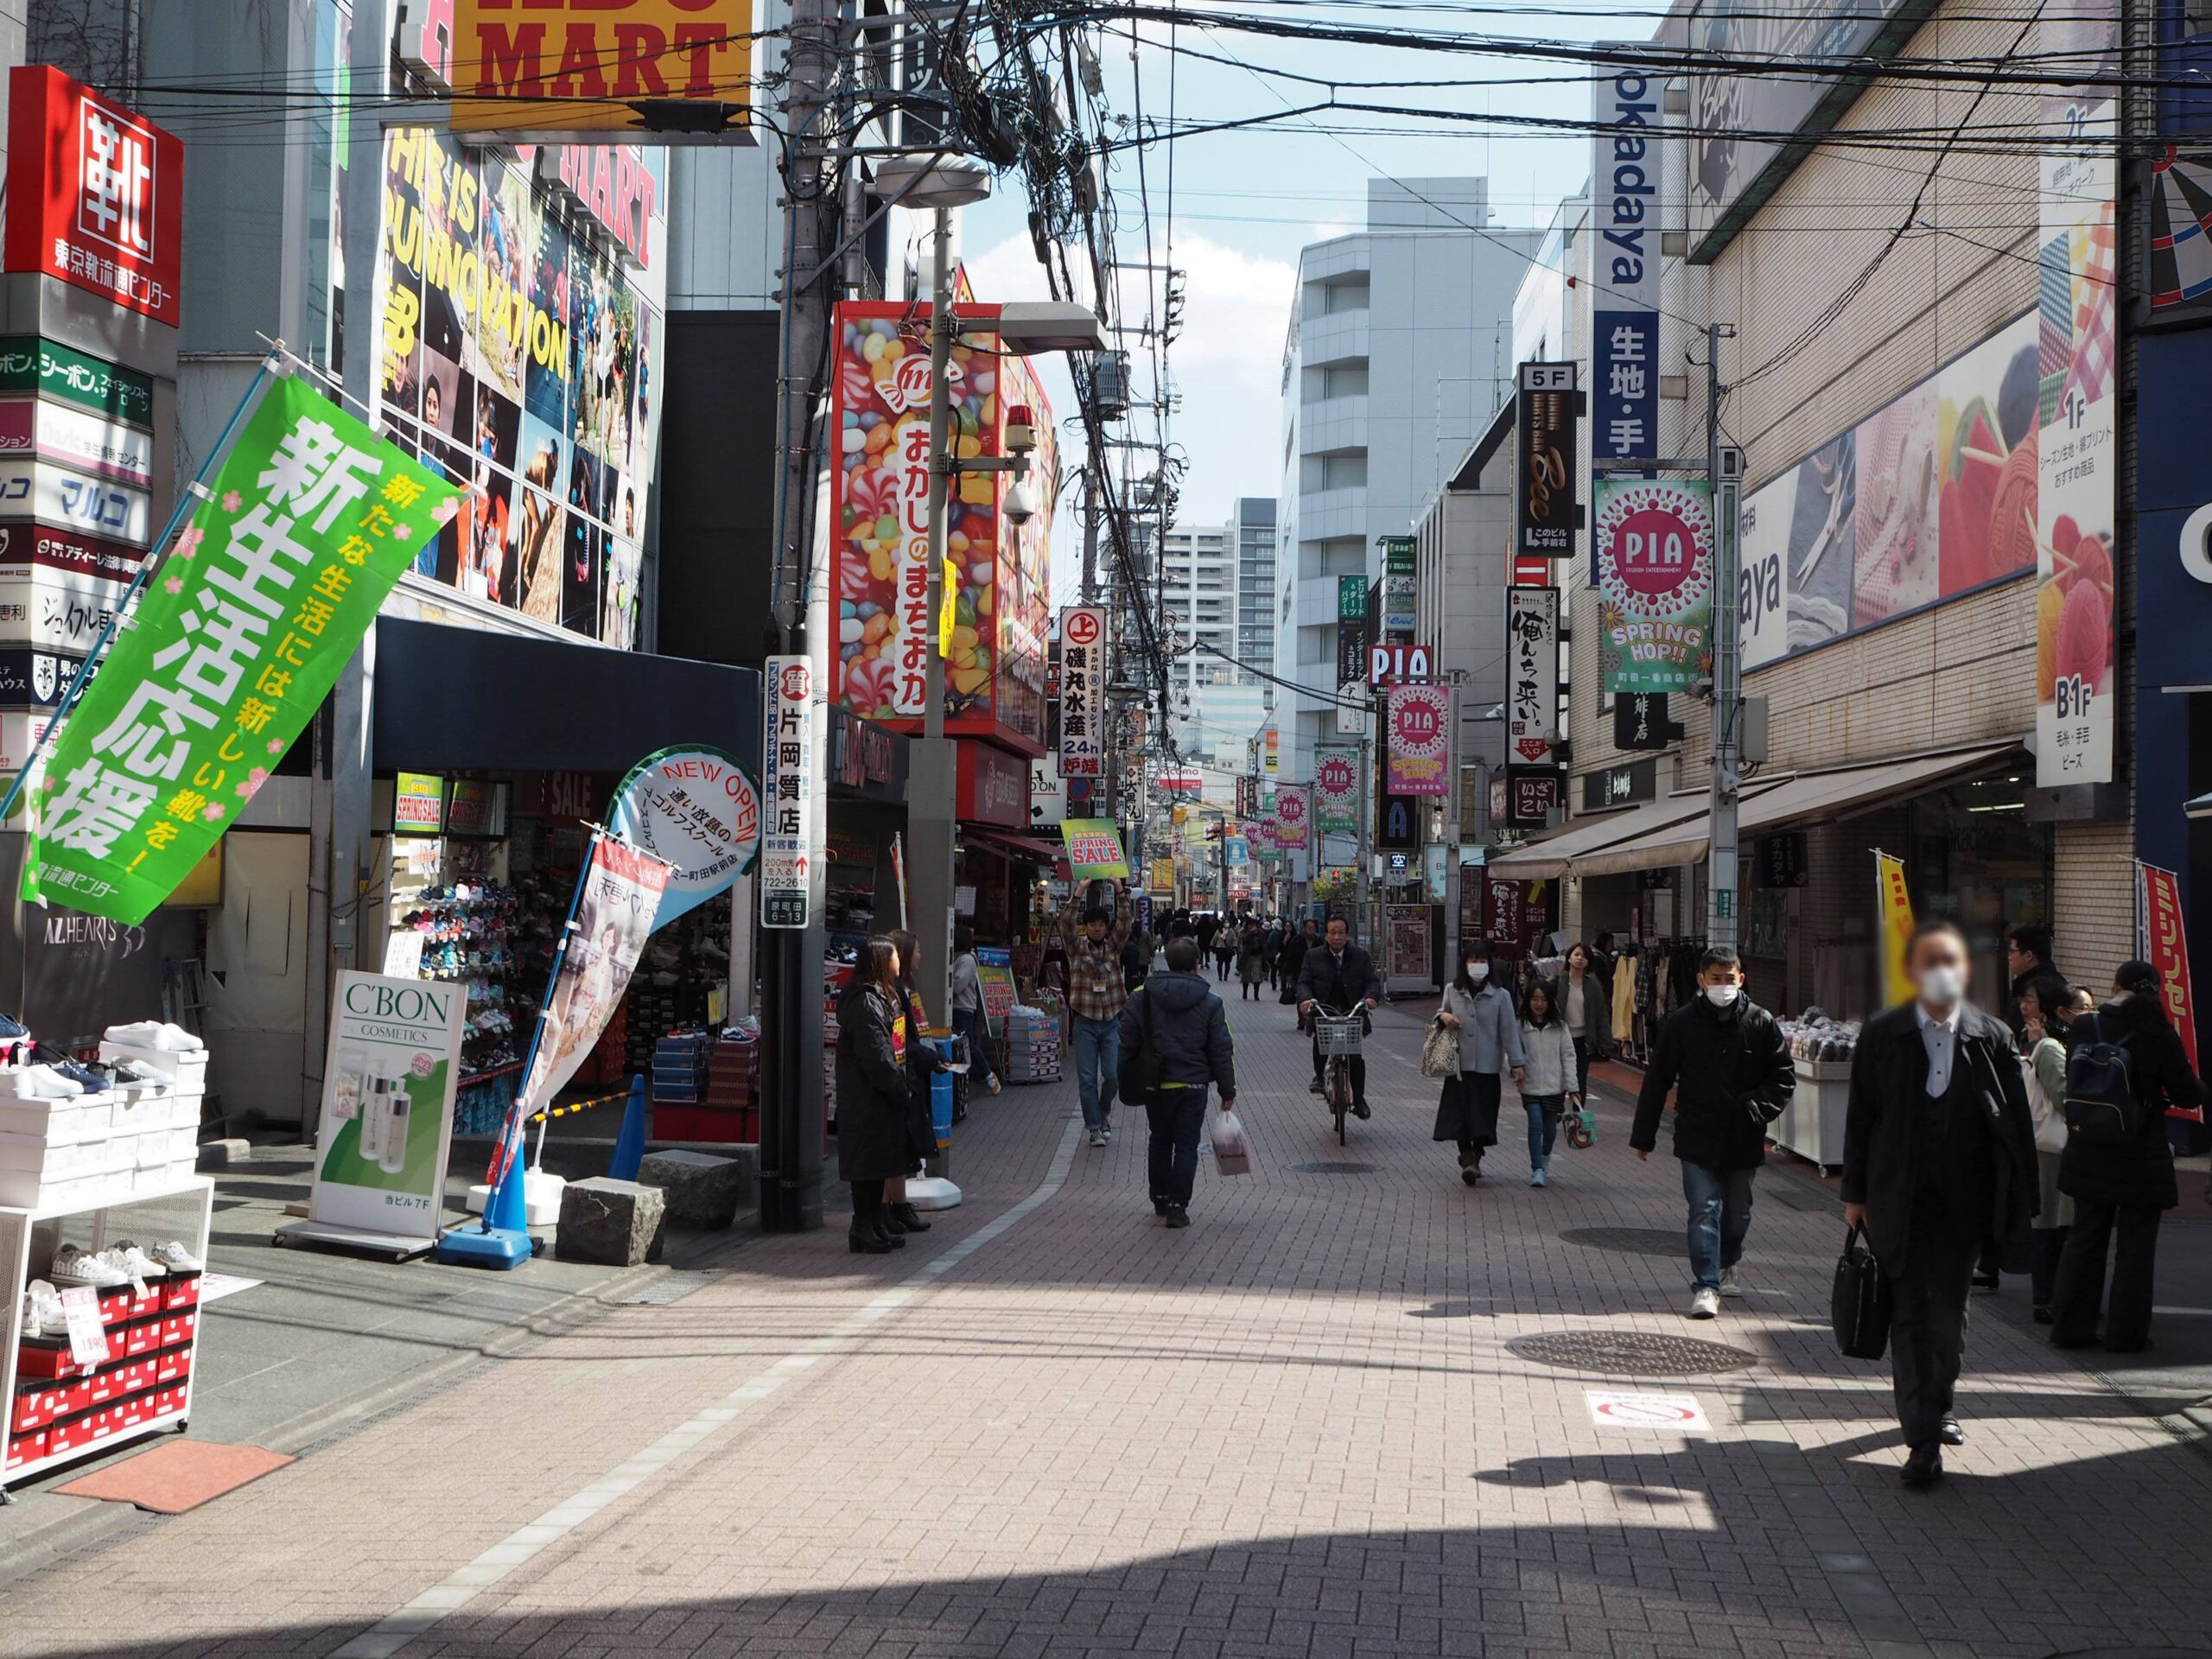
1591,478,1712,692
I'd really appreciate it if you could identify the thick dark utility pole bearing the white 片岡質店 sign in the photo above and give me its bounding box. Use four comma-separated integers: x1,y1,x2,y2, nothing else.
752,0,838,1232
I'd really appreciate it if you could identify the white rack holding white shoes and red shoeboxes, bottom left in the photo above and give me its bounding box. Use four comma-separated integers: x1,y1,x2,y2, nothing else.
0,1174,214,1502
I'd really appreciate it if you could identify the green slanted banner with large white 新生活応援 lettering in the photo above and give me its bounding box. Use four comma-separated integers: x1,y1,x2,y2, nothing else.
22,378,458,925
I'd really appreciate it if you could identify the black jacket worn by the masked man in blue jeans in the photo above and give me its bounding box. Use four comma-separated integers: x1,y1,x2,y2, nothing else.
1628,991,1796,1170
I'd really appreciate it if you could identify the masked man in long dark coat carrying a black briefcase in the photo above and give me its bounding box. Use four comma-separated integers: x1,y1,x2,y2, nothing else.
1842,923,2035,1486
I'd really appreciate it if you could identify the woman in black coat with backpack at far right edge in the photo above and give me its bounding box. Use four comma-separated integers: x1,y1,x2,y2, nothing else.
2050,963,2203,1354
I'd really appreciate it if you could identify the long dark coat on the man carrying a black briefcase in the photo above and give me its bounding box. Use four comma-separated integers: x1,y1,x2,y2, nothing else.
1842,1002,2035,1274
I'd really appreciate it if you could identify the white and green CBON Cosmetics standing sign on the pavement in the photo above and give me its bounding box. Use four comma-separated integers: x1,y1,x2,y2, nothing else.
308,969,469,1248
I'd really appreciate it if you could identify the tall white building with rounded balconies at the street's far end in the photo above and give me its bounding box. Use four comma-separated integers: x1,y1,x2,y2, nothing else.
1274,179,1540,781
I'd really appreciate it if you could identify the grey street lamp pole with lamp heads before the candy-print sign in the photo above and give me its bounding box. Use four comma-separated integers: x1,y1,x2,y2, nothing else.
869,155,1106,1039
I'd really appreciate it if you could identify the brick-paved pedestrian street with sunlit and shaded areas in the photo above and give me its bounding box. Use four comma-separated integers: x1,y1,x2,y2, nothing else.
0,1002,2212,1659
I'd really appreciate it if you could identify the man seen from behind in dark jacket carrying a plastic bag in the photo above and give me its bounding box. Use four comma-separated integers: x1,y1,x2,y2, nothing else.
1122,938,1236,1228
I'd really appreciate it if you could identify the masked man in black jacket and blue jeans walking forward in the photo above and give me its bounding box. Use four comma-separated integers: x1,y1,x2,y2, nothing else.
1628,944,1796,1319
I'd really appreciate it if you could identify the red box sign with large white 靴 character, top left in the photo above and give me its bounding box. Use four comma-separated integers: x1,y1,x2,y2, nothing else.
4,64,183,327
